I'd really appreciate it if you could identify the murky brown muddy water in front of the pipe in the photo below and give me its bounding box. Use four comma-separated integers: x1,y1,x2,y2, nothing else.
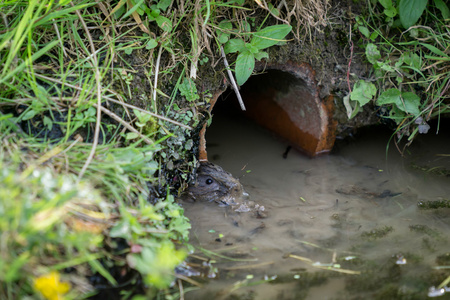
185,111,450,300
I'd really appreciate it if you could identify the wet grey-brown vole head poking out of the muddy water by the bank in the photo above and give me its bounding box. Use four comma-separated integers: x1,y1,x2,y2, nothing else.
187,162,247,205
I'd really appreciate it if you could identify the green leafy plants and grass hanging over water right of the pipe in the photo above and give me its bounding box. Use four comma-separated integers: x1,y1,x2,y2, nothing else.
344,1,450,150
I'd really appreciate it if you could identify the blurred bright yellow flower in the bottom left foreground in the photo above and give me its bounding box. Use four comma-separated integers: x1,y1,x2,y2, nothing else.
33,271,70,300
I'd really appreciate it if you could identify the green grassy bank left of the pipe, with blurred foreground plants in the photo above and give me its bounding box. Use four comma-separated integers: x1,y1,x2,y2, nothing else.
0,0,323,299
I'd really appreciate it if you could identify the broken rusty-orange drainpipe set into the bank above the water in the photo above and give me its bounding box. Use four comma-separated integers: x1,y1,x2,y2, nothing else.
200,62,336,160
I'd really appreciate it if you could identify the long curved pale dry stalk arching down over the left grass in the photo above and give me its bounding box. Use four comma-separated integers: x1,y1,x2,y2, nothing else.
70,2,102,180
